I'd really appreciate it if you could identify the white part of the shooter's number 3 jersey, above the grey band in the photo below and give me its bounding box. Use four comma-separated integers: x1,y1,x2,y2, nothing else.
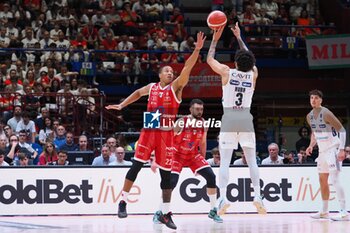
222,69,254,109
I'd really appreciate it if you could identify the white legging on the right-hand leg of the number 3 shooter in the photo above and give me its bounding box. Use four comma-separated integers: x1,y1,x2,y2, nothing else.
243,147,261,197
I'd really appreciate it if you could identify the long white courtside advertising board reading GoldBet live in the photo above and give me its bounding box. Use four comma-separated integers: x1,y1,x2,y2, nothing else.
0,167,350,215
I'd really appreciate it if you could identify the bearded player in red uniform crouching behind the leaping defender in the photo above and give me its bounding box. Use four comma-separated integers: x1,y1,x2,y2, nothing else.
171,99,222,223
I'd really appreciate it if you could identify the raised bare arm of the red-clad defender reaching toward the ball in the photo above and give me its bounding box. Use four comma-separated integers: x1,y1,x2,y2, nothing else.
173,32,206,91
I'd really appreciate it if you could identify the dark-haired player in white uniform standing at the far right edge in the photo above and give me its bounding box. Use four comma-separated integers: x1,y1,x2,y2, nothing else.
306,90,350,221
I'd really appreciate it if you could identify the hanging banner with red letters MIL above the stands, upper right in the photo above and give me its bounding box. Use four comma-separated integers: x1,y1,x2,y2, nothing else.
306,34,350,69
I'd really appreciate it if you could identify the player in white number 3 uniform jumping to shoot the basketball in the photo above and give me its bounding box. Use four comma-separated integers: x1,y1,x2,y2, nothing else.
207,23,266,214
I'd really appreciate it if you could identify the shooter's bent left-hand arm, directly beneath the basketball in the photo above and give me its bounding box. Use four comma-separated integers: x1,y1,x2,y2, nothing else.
207,27,230,84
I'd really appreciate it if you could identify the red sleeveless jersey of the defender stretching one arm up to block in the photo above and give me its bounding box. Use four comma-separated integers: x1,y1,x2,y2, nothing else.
147,83,181,127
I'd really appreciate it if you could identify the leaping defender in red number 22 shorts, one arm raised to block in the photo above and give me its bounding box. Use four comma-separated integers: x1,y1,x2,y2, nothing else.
106,32,205,229
